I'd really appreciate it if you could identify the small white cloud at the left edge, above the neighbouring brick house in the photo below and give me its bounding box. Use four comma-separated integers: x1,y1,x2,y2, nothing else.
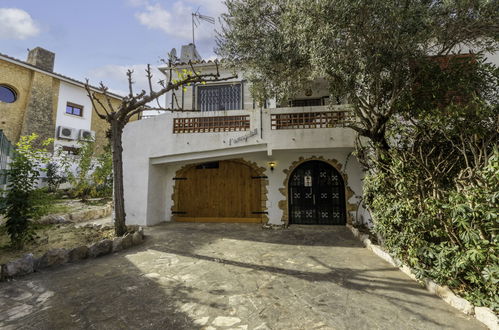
0,8,40,40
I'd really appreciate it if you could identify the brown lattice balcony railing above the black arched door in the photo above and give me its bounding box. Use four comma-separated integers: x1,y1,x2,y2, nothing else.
271,111,351,130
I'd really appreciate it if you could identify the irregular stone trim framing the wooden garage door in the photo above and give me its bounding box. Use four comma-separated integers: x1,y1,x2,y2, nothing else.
171,158,269,224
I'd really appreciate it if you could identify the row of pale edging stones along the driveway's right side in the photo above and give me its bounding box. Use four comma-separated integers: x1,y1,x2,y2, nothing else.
347,224,499,330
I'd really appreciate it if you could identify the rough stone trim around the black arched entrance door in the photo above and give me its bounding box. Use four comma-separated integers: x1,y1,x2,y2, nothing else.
277,156,358,227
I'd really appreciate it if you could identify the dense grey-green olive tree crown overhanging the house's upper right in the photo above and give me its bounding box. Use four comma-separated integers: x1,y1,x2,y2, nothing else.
217,0,499,151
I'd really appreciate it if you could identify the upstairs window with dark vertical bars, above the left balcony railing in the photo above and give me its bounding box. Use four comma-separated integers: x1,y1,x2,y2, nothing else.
197,84,242,111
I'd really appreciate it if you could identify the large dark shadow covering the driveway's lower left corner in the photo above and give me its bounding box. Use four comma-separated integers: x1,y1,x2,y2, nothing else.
0,252,208,330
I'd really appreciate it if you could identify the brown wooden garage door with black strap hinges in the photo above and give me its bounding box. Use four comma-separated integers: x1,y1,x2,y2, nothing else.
174,161,262,222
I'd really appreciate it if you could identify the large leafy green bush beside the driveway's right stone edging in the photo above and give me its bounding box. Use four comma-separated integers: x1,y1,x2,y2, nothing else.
365,141,499,310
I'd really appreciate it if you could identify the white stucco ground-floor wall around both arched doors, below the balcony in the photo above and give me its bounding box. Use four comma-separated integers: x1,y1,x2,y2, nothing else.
125,149,370,225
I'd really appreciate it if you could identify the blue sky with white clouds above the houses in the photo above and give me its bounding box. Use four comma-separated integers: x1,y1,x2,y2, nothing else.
0,0,225,95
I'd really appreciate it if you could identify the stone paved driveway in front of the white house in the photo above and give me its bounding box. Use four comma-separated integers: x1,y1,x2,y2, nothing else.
0,223,482,329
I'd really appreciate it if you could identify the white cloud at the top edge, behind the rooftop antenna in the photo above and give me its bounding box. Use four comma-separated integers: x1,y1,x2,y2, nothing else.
134,0,225,41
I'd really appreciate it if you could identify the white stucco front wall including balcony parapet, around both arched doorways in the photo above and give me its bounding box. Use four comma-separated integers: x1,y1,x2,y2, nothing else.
124,110,368,225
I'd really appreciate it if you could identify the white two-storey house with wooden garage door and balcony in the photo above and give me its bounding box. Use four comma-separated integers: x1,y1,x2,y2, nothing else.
124,46,370,225
